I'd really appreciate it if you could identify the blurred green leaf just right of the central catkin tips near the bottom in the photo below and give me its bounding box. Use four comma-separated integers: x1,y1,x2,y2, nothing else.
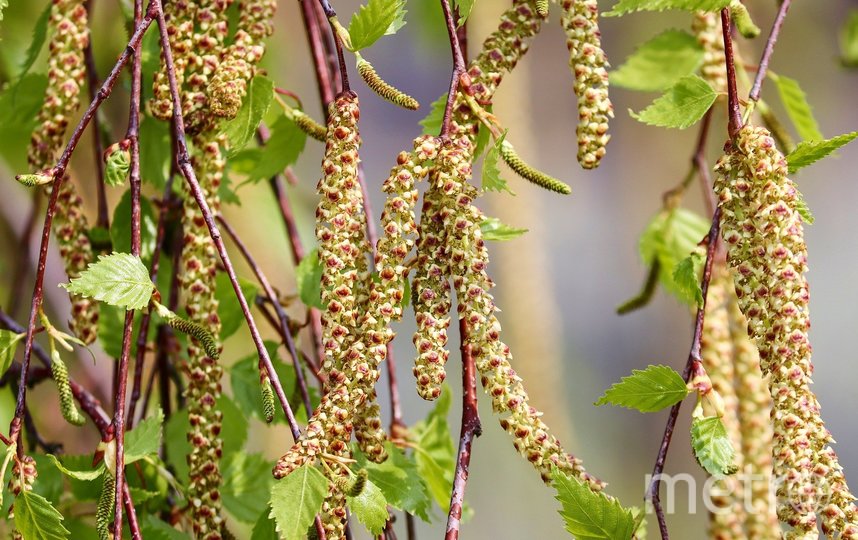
353,442,432,521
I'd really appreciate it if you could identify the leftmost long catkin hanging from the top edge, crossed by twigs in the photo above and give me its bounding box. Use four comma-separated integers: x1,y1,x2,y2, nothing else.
28,0,98,344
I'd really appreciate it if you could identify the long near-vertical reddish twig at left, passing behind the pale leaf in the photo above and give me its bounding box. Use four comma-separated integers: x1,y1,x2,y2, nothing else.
113,0,143,539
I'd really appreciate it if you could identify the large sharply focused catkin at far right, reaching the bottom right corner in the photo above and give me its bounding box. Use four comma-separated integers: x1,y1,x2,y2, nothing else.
715,126,858,539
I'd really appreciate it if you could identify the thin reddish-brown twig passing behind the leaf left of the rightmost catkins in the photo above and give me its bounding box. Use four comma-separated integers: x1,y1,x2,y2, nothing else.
647,208,721,540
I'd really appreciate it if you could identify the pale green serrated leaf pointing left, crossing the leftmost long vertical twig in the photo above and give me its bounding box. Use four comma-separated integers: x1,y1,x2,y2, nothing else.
60,252,155,309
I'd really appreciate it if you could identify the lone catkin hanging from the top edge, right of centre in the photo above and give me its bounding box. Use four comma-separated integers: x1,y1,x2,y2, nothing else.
560,0,614,169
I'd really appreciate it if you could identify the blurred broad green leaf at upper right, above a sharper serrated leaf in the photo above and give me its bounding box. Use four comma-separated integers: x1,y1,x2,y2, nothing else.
611,30,703,92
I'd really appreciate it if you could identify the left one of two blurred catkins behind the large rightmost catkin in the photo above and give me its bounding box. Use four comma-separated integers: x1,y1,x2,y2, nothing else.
700,264,745,540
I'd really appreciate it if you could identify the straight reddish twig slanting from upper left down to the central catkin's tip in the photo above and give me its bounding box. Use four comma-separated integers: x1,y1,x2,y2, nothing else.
152,4,301,440
